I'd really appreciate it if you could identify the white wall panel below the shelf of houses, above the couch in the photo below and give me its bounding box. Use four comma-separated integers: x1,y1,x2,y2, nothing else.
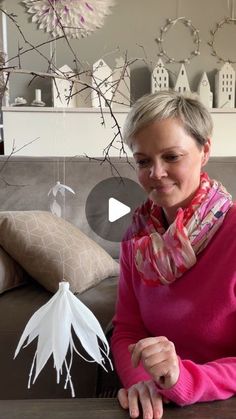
3,108,236,157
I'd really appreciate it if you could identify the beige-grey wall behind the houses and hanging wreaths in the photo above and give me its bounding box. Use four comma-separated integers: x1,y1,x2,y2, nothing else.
5,0,236,104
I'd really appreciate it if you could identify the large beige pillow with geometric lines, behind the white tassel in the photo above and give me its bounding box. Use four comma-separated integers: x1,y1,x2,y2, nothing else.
0,211,119,292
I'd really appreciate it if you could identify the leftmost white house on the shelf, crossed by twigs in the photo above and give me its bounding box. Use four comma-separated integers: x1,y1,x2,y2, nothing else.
52,65,77,108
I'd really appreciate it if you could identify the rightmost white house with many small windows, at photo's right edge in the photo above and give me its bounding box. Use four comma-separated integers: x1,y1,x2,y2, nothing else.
215,62,235,108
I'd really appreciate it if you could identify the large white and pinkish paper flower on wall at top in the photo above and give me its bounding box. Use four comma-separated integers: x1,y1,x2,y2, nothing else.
23,0,114,38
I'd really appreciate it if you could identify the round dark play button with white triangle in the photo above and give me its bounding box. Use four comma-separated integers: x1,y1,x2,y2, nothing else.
85,176,146,242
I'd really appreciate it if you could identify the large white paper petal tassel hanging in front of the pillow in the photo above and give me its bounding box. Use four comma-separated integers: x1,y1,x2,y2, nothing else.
14,282,113,397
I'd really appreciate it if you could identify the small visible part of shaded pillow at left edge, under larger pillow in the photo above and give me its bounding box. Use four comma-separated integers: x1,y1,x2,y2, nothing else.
0,247,27,294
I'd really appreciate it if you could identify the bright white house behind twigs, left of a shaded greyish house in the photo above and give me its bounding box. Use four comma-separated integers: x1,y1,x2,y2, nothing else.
91,59,113,108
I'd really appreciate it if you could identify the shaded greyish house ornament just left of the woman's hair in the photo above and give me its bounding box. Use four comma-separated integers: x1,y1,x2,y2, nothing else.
112,57,130,109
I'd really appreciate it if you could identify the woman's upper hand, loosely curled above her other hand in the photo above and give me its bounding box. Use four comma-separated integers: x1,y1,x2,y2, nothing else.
129,336,179,389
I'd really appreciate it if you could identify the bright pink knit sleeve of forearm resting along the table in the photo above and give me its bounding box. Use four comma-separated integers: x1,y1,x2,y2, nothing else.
157,357,236,406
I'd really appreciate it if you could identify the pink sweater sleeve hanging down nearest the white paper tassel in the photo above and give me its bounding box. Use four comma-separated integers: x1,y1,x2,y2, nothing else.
111,241,151,389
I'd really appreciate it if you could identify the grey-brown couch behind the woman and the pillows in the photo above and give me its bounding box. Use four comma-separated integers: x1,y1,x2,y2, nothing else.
0,156,236,399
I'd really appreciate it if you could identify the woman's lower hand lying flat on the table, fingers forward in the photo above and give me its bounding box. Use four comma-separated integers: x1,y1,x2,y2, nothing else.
117,381,163,419
